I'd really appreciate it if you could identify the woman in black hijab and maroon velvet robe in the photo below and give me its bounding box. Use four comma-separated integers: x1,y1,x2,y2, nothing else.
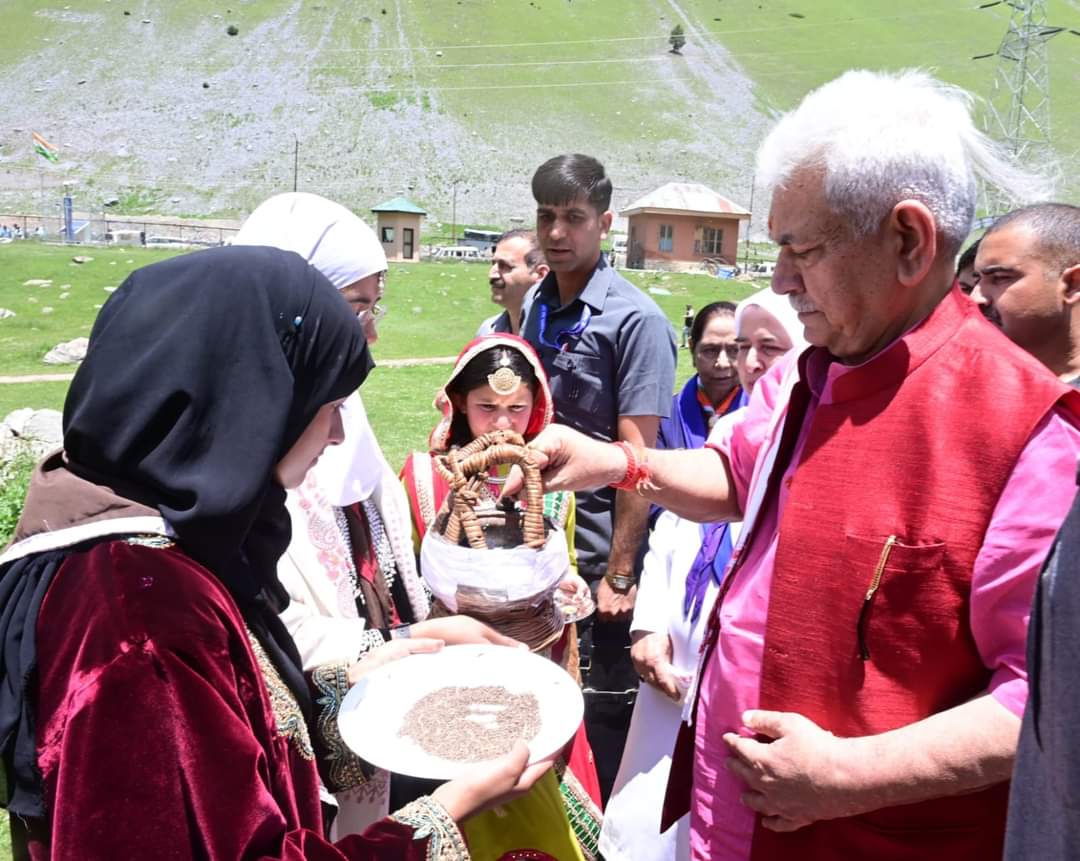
0,248,536,861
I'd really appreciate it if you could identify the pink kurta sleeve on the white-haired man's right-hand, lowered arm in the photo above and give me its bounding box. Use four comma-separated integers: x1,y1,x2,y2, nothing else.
971,411,1080,715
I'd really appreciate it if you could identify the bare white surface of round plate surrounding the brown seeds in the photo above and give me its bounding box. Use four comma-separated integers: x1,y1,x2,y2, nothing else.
338,646,584,780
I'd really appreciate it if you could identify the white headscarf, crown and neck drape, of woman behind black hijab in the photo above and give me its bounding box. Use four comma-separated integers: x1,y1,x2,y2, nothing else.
233,191,389,507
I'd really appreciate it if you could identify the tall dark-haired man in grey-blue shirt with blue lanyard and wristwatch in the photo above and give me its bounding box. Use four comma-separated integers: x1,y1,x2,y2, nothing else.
522,154,676,799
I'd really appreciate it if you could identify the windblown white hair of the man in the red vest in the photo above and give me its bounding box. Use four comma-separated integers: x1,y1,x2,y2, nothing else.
757,69,1052,255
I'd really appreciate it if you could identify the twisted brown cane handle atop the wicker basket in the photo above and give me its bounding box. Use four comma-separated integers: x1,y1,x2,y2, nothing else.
435,431,544,550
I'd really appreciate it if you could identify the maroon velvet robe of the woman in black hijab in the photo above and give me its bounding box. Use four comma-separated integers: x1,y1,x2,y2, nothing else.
30,540,451,861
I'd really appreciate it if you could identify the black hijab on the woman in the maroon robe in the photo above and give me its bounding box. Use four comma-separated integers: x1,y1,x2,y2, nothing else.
0,247,373,817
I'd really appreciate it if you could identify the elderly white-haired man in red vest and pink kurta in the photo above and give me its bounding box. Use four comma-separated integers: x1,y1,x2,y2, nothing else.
511,71,1080,861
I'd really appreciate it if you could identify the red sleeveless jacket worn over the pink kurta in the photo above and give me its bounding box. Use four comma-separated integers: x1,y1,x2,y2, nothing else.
673,290,1080,861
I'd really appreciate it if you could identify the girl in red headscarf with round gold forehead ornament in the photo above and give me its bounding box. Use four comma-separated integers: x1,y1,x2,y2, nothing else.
402,335,600,861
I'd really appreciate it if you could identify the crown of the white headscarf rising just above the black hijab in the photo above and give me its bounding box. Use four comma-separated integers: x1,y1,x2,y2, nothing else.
232,191,387,290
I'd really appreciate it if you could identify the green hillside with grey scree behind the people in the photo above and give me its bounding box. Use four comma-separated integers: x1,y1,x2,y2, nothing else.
0,0,1080,224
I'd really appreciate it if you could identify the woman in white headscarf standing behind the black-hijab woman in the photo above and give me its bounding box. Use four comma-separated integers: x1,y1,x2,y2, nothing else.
233,192,516,835
